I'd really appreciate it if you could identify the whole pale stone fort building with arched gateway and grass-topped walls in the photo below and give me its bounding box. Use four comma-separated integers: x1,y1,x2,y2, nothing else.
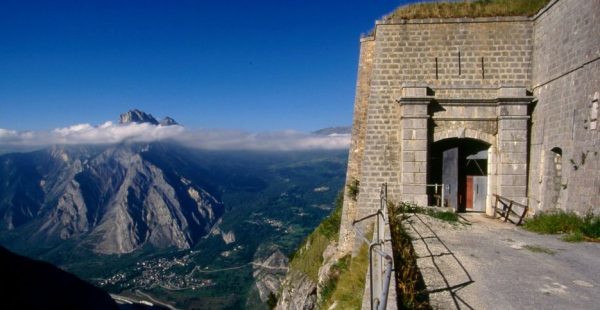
339,0,600,251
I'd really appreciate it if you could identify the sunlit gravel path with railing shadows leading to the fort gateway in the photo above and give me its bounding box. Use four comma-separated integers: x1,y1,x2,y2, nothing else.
403,213,600,310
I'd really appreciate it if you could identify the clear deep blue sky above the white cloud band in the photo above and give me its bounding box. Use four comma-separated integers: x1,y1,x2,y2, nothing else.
0,0,412,132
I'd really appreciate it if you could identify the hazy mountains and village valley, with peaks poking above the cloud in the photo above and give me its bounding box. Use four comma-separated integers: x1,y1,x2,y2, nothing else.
0,110,347,308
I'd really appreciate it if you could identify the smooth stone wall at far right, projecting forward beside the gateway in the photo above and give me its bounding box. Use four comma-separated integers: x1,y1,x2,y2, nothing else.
528,0,600,214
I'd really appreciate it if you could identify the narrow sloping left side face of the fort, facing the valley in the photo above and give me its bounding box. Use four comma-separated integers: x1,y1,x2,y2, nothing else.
338,37,375,253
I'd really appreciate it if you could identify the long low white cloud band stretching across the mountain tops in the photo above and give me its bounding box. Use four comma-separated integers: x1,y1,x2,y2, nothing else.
0,122,350,153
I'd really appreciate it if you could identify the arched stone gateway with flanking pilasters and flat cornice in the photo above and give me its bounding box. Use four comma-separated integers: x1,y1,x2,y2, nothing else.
397,85,532,211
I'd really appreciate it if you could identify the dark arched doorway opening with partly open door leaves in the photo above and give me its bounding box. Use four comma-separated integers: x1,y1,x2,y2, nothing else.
428,138,490,212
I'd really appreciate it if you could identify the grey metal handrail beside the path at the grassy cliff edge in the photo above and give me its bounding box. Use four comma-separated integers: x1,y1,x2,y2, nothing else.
352,183,393,310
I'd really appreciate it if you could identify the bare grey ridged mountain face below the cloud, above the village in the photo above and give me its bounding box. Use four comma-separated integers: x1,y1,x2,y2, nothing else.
0,144,223,254
